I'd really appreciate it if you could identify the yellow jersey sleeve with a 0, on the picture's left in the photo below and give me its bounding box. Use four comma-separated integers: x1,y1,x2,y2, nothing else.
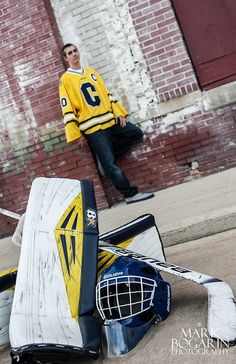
59,80,82,143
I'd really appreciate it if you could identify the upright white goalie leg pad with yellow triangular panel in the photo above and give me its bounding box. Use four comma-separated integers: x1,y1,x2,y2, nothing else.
10,178,98,362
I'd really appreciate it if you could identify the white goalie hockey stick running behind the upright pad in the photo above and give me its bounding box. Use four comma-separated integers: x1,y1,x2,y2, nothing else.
0,209,236,344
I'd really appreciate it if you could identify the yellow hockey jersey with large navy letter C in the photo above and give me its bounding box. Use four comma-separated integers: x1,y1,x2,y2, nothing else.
59,68,128,143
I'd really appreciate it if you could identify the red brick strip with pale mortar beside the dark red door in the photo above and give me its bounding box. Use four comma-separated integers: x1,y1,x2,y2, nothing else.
128,0,198,102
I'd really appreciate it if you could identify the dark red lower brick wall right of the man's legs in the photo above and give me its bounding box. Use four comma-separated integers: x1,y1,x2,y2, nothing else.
102,105,236,203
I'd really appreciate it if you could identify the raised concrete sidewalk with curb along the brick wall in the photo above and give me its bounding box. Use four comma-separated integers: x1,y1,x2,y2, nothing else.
99,168,236,246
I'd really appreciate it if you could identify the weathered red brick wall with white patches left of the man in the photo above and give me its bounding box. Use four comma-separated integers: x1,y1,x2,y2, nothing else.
0,0,107,237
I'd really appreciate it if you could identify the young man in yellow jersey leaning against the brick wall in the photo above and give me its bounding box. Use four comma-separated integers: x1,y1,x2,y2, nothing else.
59,44,154,203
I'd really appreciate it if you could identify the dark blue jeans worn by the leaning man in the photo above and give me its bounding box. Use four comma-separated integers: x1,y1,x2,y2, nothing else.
85,122,143,198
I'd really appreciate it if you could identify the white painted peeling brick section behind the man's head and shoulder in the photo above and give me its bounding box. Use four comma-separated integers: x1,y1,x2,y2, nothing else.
51,0,157,122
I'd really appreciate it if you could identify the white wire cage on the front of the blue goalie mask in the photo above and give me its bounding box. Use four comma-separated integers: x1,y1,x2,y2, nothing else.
96,275,157,321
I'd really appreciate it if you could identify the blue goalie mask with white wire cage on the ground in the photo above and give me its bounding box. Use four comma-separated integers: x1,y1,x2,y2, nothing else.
96,257,171,357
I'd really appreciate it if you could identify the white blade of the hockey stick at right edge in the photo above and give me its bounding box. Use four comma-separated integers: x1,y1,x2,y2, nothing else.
203,280,236,345
